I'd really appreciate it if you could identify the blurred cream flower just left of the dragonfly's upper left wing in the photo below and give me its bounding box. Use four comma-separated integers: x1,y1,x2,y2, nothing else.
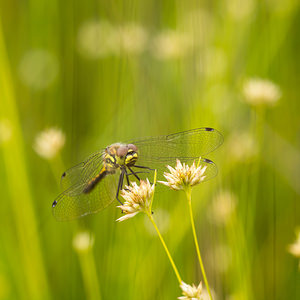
33,128,65,159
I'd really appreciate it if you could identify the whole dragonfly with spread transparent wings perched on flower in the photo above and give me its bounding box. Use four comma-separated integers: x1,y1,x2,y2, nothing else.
52,127,223,221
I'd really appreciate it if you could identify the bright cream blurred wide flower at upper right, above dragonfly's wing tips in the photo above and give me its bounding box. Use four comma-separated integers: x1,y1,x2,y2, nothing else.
243,78,281,106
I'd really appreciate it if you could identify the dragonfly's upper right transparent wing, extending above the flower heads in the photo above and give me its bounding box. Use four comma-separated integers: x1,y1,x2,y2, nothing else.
132,127,223,160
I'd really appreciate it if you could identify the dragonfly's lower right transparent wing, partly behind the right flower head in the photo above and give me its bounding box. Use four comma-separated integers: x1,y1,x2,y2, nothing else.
130,158,218,182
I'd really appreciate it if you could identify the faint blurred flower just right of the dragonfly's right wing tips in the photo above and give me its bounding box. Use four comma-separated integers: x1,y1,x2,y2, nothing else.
227,132,257,161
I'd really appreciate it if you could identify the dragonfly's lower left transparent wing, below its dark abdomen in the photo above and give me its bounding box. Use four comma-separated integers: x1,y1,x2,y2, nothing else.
52,170,120,221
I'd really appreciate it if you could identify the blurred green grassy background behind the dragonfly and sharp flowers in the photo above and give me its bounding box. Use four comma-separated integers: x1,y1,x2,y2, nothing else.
0,0,300,300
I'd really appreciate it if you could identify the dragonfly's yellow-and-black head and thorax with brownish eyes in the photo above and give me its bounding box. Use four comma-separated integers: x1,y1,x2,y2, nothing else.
104,143,138,169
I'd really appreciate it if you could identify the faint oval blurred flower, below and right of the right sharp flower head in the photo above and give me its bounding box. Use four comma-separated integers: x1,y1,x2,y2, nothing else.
209,191,237,225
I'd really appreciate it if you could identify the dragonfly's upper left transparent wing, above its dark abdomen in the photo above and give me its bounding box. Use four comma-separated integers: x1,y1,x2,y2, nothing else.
60,151,103,193
